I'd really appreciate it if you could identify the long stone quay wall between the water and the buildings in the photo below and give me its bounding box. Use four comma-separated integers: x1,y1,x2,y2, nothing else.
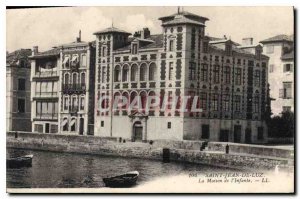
7,132,294,170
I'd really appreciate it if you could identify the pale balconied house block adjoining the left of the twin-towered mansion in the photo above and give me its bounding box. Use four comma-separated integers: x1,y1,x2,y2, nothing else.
31,36,95,135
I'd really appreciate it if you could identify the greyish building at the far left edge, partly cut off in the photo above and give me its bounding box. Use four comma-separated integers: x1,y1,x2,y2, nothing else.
6,49,31,132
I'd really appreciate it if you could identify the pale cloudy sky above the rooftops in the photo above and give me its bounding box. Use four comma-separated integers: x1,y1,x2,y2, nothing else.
6,6,294,52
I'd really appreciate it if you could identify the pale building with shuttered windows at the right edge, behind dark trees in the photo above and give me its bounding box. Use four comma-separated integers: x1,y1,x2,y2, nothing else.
260,35,295,116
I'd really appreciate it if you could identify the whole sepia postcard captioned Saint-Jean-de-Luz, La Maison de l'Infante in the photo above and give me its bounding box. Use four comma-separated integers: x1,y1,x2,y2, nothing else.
6,6,295,193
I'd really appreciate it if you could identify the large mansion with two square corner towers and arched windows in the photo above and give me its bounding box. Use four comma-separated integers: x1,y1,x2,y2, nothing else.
94,11,268,143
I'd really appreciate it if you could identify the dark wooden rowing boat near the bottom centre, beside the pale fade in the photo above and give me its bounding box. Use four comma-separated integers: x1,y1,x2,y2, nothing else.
103,171,139,187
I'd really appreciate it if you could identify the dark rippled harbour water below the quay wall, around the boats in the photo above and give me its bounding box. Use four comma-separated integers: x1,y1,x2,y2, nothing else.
6,148,241,188
